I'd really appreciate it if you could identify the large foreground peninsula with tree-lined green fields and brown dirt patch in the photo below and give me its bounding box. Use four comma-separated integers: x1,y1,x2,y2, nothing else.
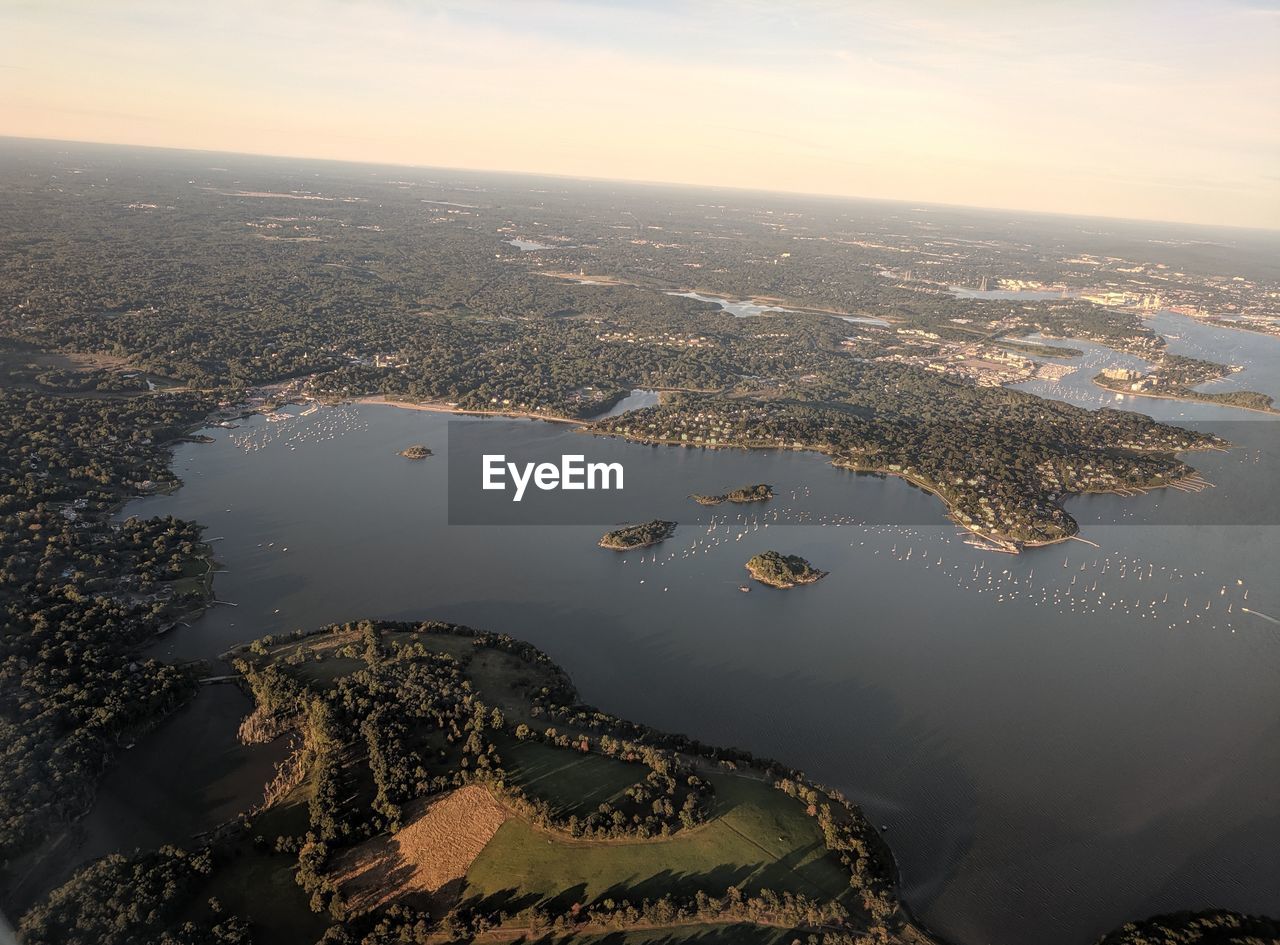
22,621,936,945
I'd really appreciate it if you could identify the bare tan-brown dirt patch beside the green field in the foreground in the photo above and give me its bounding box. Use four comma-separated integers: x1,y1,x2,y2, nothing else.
333,785,511,912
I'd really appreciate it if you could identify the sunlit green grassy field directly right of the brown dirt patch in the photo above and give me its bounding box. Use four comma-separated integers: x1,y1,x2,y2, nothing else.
465,776,849,909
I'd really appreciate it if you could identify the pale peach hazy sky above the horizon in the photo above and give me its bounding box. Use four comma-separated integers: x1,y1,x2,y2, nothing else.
0,0,1280,228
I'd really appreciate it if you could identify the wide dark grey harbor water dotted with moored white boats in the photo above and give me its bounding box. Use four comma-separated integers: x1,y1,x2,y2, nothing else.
104,401,1280,941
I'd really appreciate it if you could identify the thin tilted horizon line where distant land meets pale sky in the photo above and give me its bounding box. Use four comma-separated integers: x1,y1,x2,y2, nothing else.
0,132,1280,234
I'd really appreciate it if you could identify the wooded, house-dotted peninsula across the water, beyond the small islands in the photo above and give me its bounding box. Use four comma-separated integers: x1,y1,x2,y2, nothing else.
591,391,1226,551
